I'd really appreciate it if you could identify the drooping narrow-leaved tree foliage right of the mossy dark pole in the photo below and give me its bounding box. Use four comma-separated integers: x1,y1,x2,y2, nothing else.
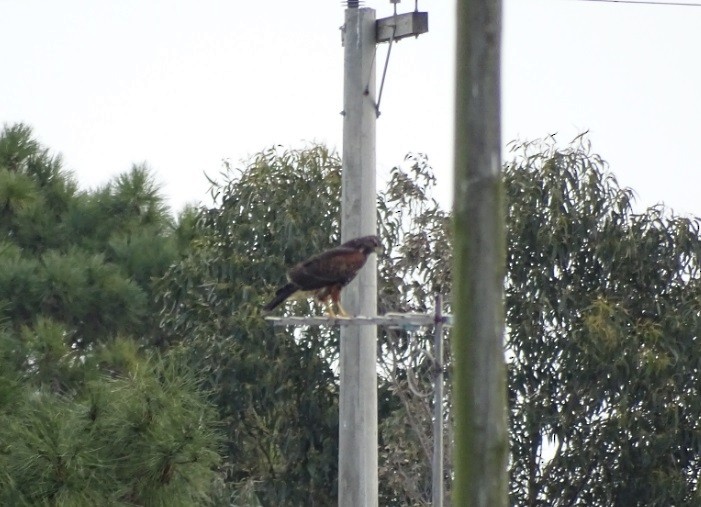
506,140,701,506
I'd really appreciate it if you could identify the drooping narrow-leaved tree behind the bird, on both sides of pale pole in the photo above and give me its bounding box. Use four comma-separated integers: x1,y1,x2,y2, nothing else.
160,146,449,505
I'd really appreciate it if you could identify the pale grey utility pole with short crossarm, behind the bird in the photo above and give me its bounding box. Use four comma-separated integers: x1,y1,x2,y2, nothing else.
338,0,428,507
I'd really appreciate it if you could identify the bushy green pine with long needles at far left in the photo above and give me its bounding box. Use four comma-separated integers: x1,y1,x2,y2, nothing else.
0,125,219,505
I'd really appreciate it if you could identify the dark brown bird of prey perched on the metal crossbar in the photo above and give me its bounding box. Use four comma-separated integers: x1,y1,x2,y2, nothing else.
263,236,382,317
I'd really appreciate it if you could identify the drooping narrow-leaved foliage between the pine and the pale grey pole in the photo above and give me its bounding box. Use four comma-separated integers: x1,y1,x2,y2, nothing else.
159,146,340,505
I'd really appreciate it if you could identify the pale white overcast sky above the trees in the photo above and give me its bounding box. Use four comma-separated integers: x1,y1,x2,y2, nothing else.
0,0,701,215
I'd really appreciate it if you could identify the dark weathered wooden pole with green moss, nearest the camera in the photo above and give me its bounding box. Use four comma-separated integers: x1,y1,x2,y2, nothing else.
452,0,508,507
